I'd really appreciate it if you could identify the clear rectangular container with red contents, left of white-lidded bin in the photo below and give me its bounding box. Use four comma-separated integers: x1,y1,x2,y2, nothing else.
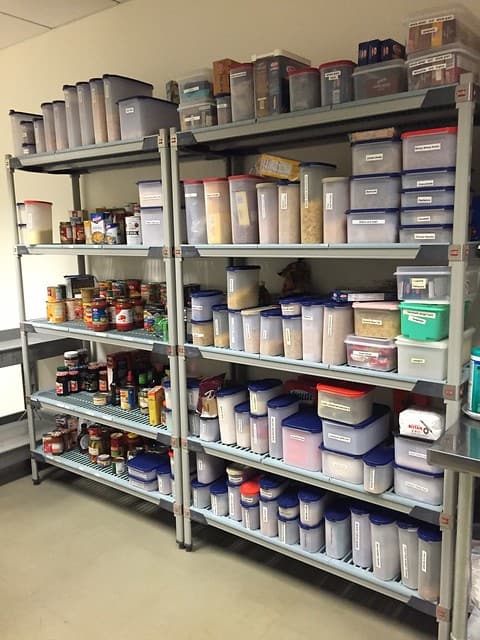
345,335,397,371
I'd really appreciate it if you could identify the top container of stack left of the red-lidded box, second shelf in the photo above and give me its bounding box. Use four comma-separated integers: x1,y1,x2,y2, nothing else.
352,138,402,176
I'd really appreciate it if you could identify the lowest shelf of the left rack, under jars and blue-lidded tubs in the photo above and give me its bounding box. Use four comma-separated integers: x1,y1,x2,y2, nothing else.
31,447,175,512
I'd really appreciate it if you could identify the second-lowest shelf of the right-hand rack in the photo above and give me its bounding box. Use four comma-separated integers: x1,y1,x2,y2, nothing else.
187,436,442,524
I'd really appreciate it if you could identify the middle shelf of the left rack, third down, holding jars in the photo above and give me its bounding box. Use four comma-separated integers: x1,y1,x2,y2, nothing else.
21,319,173,355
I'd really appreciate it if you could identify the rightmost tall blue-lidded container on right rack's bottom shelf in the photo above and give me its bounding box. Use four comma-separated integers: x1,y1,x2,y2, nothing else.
418,527,442,602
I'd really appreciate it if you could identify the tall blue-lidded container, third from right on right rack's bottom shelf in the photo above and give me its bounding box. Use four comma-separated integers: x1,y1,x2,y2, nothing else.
370,511,400,580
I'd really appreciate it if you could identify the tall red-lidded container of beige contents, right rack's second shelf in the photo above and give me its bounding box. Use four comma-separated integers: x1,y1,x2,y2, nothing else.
203,178,232,244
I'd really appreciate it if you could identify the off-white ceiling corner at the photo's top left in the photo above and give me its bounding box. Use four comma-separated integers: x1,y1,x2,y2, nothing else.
0,0,128,49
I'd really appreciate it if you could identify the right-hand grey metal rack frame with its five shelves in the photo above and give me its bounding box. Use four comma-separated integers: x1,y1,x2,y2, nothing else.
170,80,480,640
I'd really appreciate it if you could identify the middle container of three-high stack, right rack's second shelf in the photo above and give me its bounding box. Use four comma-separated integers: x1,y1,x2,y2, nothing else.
350,173,401,209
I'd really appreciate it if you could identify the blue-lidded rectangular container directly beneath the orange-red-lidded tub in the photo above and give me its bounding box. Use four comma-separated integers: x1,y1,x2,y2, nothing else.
323,404,390,455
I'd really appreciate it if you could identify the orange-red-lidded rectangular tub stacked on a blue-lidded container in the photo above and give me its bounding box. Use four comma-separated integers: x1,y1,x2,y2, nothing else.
317,382,374,424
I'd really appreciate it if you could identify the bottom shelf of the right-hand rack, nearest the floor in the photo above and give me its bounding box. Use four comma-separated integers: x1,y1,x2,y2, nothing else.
190,507,436,616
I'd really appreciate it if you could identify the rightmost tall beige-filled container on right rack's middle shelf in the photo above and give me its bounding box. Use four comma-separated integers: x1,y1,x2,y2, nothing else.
322,302,353,364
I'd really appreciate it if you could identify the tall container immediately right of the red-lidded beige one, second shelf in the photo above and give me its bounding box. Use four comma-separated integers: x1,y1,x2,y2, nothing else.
228,174,263,244
